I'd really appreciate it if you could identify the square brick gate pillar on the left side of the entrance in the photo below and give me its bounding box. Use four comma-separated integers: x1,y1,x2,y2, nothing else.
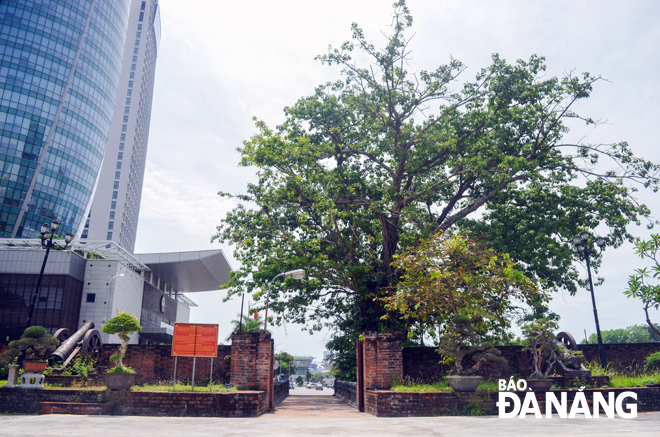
230,332,273,398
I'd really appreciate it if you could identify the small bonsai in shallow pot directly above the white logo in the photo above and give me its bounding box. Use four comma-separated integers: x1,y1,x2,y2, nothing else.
522,318,566,390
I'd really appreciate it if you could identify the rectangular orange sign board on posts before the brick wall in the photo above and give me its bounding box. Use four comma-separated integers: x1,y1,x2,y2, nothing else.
172,323,218,357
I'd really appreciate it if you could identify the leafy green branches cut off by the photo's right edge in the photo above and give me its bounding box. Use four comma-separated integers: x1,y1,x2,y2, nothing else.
624,234,660,335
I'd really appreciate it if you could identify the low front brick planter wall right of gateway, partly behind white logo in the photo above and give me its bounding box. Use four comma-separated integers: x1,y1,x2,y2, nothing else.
365,387,660,417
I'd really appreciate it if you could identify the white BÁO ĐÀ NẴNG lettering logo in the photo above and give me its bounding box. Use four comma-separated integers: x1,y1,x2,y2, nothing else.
496,377,637,419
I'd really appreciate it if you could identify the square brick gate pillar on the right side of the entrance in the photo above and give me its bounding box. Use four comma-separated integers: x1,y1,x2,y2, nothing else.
362,332,403,390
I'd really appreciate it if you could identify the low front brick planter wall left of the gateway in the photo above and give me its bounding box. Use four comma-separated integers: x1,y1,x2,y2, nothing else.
0,387,268,417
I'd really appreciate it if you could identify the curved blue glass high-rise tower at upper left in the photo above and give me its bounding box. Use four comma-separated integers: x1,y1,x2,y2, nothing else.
0,0,130,238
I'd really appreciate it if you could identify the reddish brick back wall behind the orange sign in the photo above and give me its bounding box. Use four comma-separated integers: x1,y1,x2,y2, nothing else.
101,344,231,384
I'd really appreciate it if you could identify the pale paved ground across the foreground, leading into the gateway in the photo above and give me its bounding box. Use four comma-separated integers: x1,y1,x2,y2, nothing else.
0,389,660,437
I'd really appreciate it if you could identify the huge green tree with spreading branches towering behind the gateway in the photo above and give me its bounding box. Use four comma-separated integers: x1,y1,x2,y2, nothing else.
213,1,658,377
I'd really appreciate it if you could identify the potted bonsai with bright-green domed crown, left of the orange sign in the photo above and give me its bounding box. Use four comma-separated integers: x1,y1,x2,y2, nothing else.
102,313,142,390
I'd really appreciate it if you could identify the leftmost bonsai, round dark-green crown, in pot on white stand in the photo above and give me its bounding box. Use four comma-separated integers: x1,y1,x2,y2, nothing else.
0,326,60,388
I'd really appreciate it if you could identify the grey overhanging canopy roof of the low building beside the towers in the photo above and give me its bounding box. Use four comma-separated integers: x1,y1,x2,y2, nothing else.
135,249,232,293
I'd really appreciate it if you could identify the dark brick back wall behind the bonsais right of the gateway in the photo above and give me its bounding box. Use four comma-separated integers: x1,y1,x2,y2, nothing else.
403,343,660,382
